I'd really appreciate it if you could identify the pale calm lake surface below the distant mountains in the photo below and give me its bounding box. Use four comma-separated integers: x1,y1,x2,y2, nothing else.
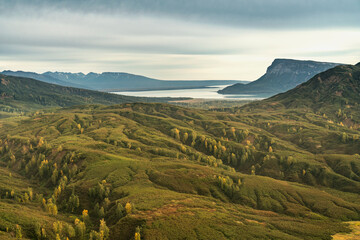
114,85,264,100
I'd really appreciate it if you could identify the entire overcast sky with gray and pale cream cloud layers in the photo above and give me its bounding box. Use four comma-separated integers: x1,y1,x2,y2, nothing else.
0,0,360,80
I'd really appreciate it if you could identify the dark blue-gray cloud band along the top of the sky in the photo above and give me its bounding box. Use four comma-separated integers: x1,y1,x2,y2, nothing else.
0,0,360,28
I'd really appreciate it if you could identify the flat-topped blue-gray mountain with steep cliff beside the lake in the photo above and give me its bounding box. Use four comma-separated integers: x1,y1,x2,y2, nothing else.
218,59,340,96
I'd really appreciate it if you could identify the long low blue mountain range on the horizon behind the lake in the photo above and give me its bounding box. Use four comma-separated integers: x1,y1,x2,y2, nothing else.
2,71,248,92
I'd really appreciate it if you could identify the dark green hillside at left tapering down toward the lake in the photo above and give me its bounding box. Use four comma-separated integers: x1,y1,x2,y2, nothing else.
0,74,186,116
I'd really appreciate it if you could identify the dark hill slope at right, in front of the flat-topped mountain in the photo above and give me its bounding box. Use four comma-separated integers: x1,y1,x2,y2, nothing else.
247,63,360,117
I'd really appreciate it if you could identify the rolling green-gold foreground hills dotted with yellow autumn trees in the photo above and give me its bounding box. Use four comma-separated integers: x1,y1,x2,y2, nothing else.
0,103,360,239
